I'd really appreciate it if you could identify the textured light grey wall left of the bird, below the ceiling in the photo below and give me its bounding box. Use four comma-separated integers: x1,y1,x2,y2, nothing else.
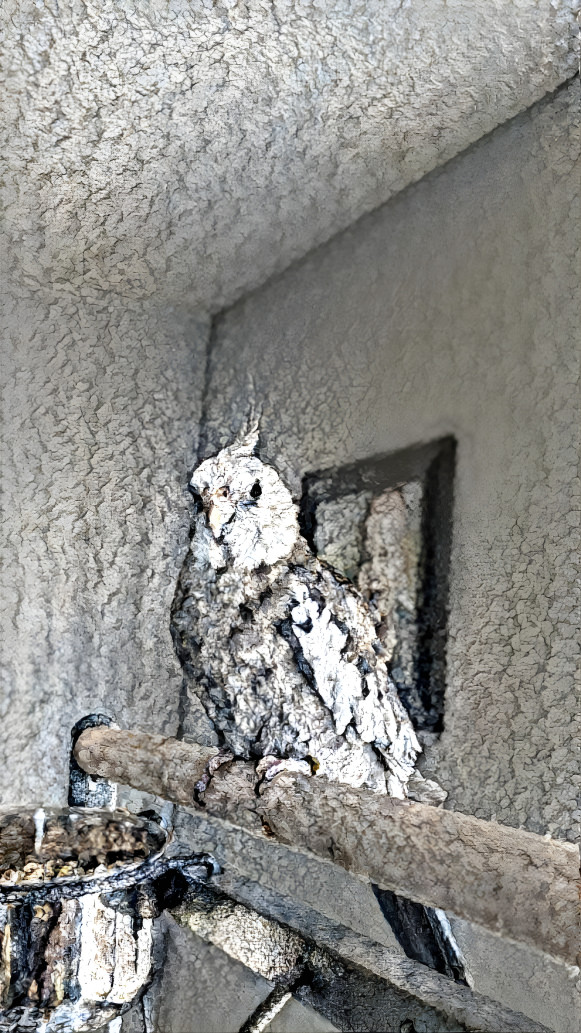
0,290,207,804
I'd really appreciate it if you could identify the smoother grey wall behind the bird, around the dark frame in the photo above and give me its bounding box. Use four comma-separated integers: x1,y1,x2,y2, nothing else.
201,81,581,837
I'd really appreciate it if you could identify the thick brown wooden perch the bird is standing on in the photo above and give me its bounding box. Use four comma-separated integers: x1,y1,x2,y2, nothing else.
75,726,580,964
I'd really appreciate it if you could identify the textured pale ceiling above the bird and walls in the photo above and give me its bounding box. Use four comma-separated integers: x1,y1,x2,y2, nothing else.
2,0,577,311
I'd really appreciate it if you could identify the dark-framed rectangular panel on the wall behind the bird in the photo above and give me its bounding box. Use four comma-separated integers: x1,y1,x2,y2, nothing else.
301,437,456,743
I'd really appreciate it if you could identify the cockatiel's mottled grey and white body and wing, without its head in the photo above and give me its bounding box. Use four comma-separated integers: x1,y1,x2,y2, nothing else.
174,524,417,795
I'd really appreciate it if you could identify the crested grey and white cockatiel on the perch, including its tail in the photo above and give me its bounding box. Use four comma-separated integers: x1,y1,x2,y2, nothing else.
172,420,465,981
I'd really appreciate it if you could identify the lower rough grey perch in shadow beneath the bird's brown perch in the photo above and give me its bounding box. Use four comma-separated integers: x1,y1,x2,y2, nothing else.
170,877,549,1033
